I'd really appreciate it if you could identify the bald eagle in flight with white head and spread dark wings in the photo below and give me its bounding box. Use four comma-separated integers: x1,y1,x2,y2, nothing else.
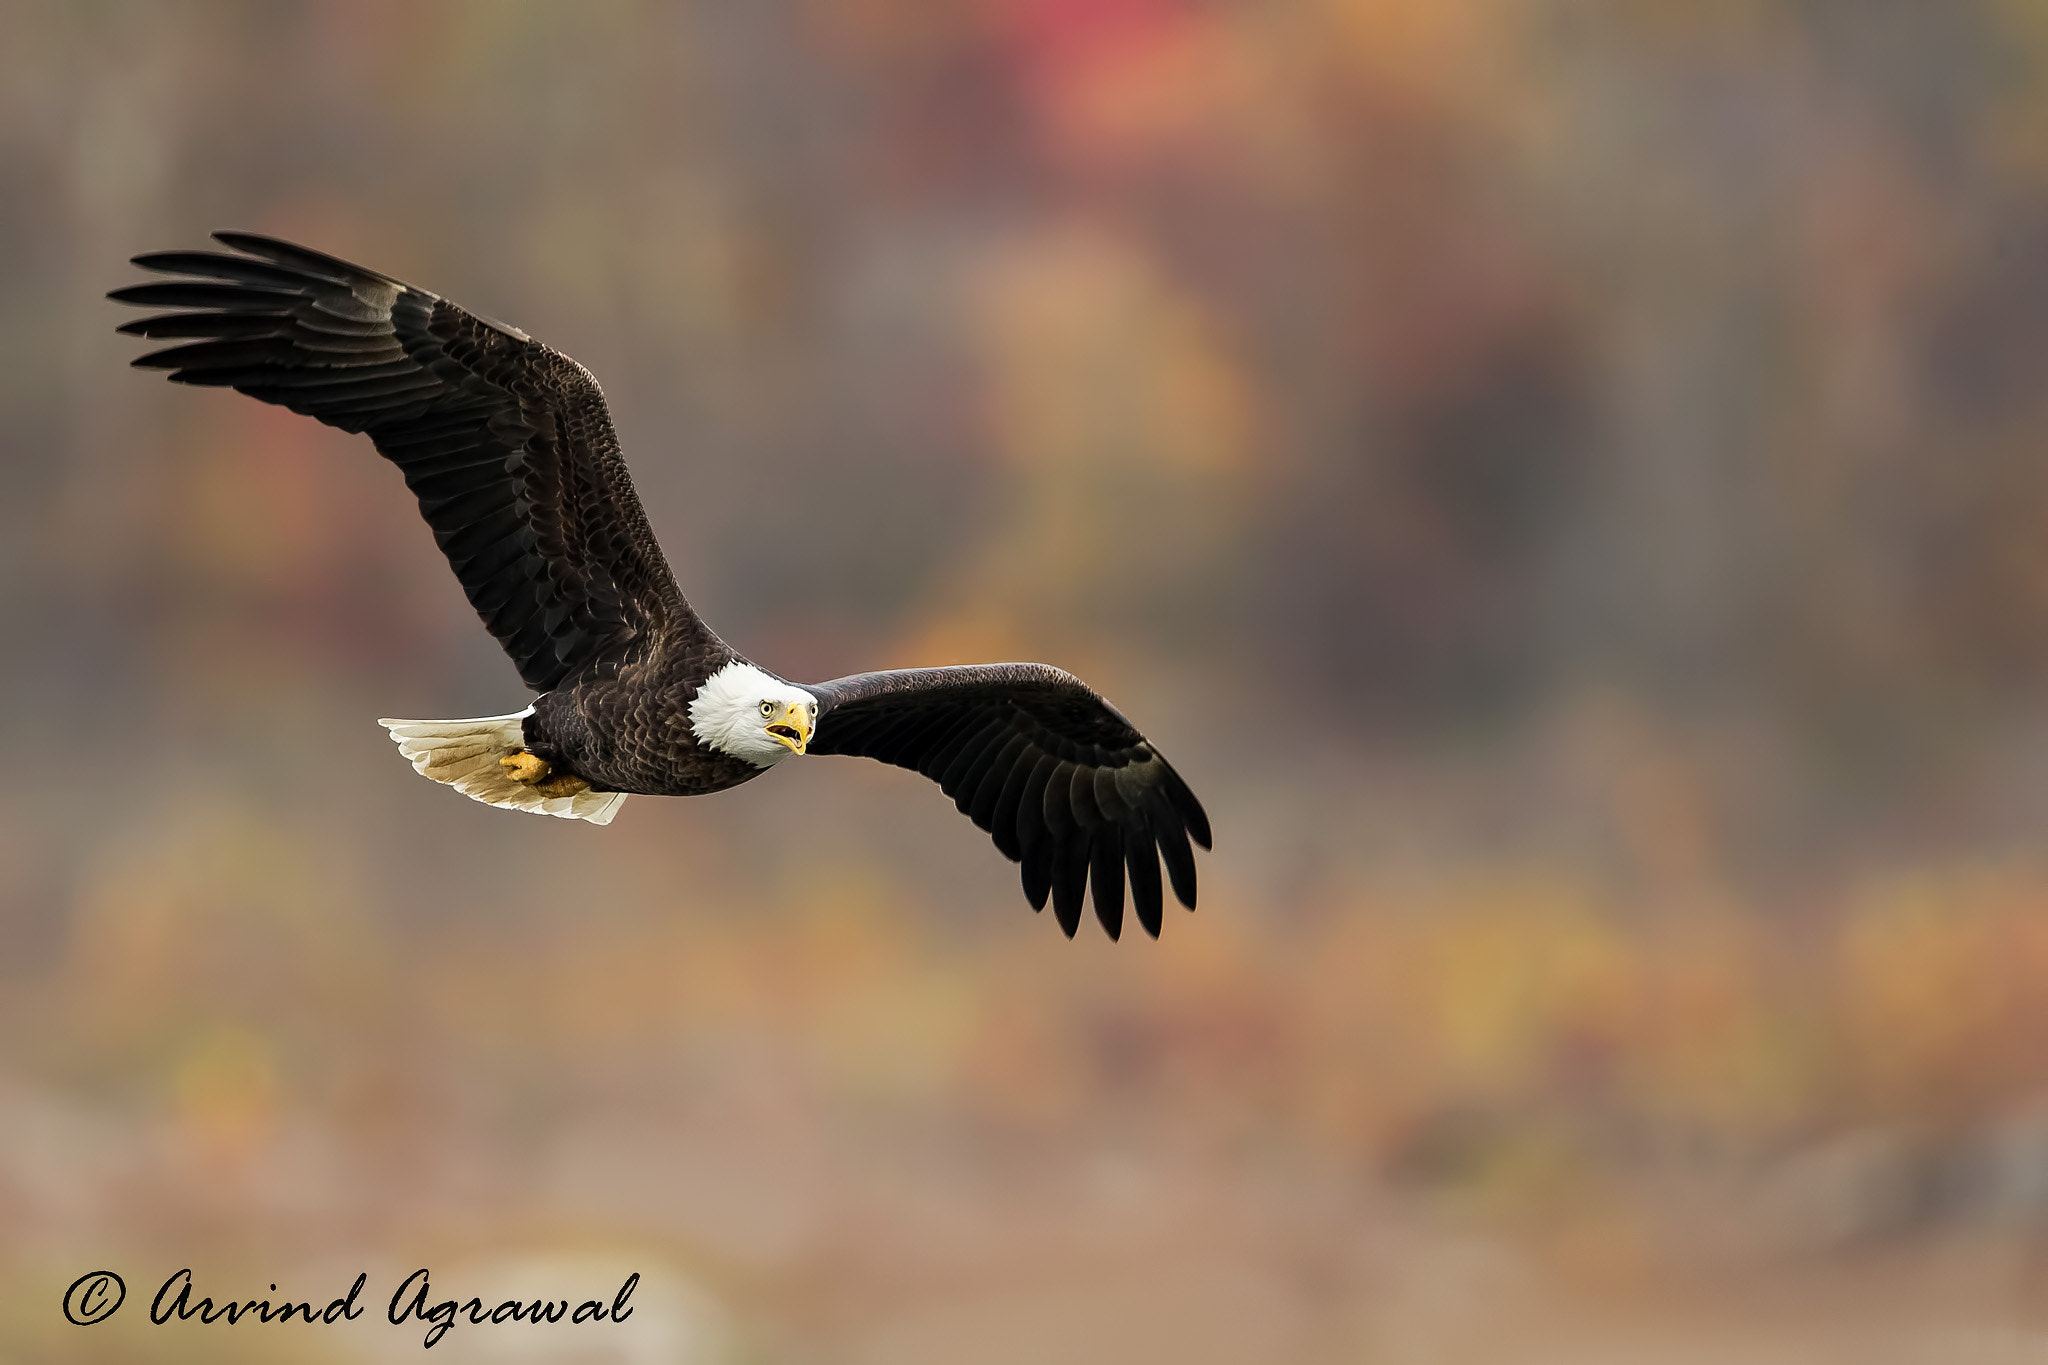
109,231,1210,939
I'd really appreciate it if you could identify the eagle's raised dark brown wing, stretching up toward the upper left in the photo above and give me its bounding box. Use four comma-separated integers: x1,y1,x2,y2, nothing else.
111,231,709,692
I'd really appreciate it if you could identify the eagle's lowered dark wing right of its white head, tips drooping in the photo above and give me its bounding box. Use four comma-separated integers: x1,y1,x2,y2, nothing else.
809,663,1208,939
